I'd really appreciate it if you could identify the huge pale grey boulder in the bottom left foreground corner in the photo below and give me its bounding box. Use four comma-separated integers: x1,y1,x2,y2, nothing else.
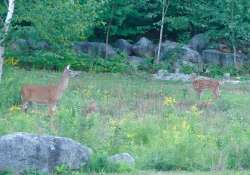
0,133,91,174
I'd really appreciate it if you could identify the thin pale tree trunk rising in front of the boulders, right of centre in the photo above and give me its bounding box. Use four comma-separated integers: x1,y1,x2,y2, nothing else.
156,0,170,64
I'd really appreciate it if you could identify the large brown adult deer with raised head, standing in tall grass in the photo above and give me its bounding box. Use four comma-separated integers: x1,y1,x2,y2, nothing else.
21,65,74,116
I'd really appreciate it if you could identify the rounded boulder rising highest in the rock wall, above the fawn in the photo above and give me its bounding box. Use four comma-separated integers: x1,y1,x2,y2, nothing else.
188,33,209,53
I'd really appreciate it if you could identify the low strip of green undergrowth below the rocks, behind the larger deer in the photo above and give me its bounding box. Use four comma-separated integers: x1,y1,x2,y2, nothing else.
5,50,132,72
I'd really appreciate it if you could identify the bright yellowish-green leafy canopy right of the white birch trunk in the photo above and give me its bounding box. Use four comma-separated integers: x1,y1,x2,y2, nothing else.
10,0,105,47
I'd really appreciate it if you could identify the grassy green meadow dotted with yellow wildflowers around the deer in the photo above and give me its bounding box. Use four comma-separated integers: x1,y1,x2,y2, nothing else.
0,67,250,175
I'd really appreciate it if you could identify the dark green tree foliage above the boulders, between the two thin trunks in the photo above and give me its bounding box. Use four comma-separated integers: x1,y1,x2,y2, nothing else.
95,0,155,40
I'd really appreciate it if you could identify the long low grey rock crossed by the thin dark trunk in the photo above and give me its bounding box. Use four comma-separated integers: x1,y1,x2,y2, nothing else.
73,41,116,58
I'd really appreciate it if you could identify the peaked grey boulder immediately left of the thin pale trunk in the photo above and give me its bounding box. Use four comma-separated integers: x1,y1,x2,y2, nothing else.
132,37,155,58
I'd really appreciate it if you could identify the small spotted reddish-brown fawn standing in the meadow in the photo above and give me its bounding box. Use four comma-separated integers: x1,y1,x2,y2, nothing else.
191,75,220,98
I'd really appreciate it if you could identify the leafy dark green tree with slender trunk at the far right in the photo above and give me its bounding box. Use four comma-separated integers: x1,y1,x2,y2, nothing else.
208,0,250,68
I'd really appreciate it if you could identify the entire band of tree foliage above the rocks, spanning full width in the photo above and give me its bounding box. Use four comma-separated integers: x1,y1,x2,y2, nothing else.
0,0,250,47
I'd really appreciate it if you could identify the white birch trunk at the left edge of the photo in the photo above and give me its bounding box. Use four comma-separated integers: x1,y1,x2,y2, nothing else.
0,0,15,81
